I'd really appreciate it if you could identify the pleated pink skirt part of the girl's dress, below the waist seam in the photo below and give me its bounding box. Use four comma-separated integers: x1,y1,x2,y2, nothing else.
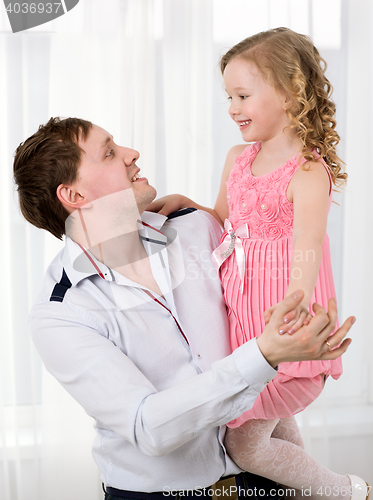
220,236,342,427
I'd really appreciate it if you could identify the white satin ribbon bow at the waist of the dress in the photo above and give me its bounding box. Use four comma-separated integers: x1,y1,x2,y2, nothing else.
212,219,250,293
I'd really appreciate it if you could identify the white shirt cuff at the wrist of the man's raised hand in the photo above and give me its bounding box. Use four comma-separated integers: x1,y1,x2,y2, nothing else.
232,338,277,392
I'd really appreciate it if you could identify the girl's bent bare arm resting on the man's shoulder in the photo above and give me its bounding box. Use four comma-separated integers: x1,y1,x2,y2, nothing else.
147,144,247,225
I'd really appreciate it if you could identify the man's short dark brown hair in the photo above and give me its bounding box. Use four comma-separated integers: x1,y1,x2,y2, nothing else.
13,117,92,239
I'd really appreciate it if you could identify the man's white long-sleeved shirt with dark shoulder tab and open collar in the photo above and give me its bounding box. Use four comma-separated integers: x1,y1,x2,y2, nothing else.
30,211,276,492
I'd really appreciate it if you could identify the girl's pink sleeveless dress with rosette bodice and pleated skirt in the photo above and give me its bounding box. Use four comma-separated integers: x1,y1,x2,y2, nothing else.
214,142,342,427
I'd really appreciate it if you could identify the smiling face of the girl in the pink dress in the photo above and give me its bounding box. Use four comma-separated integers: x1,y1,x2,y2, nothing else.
224,58,290,142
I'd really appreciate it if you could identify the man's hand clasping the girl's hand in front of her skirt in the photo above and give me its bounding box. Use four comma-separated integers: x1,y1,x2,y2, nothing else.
258,290,355,367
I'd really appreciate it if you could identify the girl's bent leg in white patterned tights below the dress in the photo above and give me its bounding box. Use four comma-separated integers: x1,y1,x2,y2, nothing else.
225,420,350,500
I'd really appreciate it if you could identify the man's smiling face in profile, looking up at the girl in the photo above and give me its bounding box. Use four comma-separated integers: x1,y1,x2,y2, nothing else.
74,125,157,213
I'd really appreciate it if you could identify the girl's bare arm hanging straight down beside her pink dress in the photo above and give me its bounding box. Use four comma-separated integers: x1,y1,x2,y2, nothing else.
284,161,331,333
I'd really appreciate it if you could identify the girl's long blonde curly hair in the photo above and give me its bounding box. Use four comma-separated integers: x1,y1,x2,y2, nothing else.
220,28,347,186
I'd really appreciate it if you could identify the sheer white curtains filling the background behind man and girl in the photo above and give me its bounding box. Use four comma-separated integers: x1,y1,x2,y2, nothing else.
0,0,373,500
